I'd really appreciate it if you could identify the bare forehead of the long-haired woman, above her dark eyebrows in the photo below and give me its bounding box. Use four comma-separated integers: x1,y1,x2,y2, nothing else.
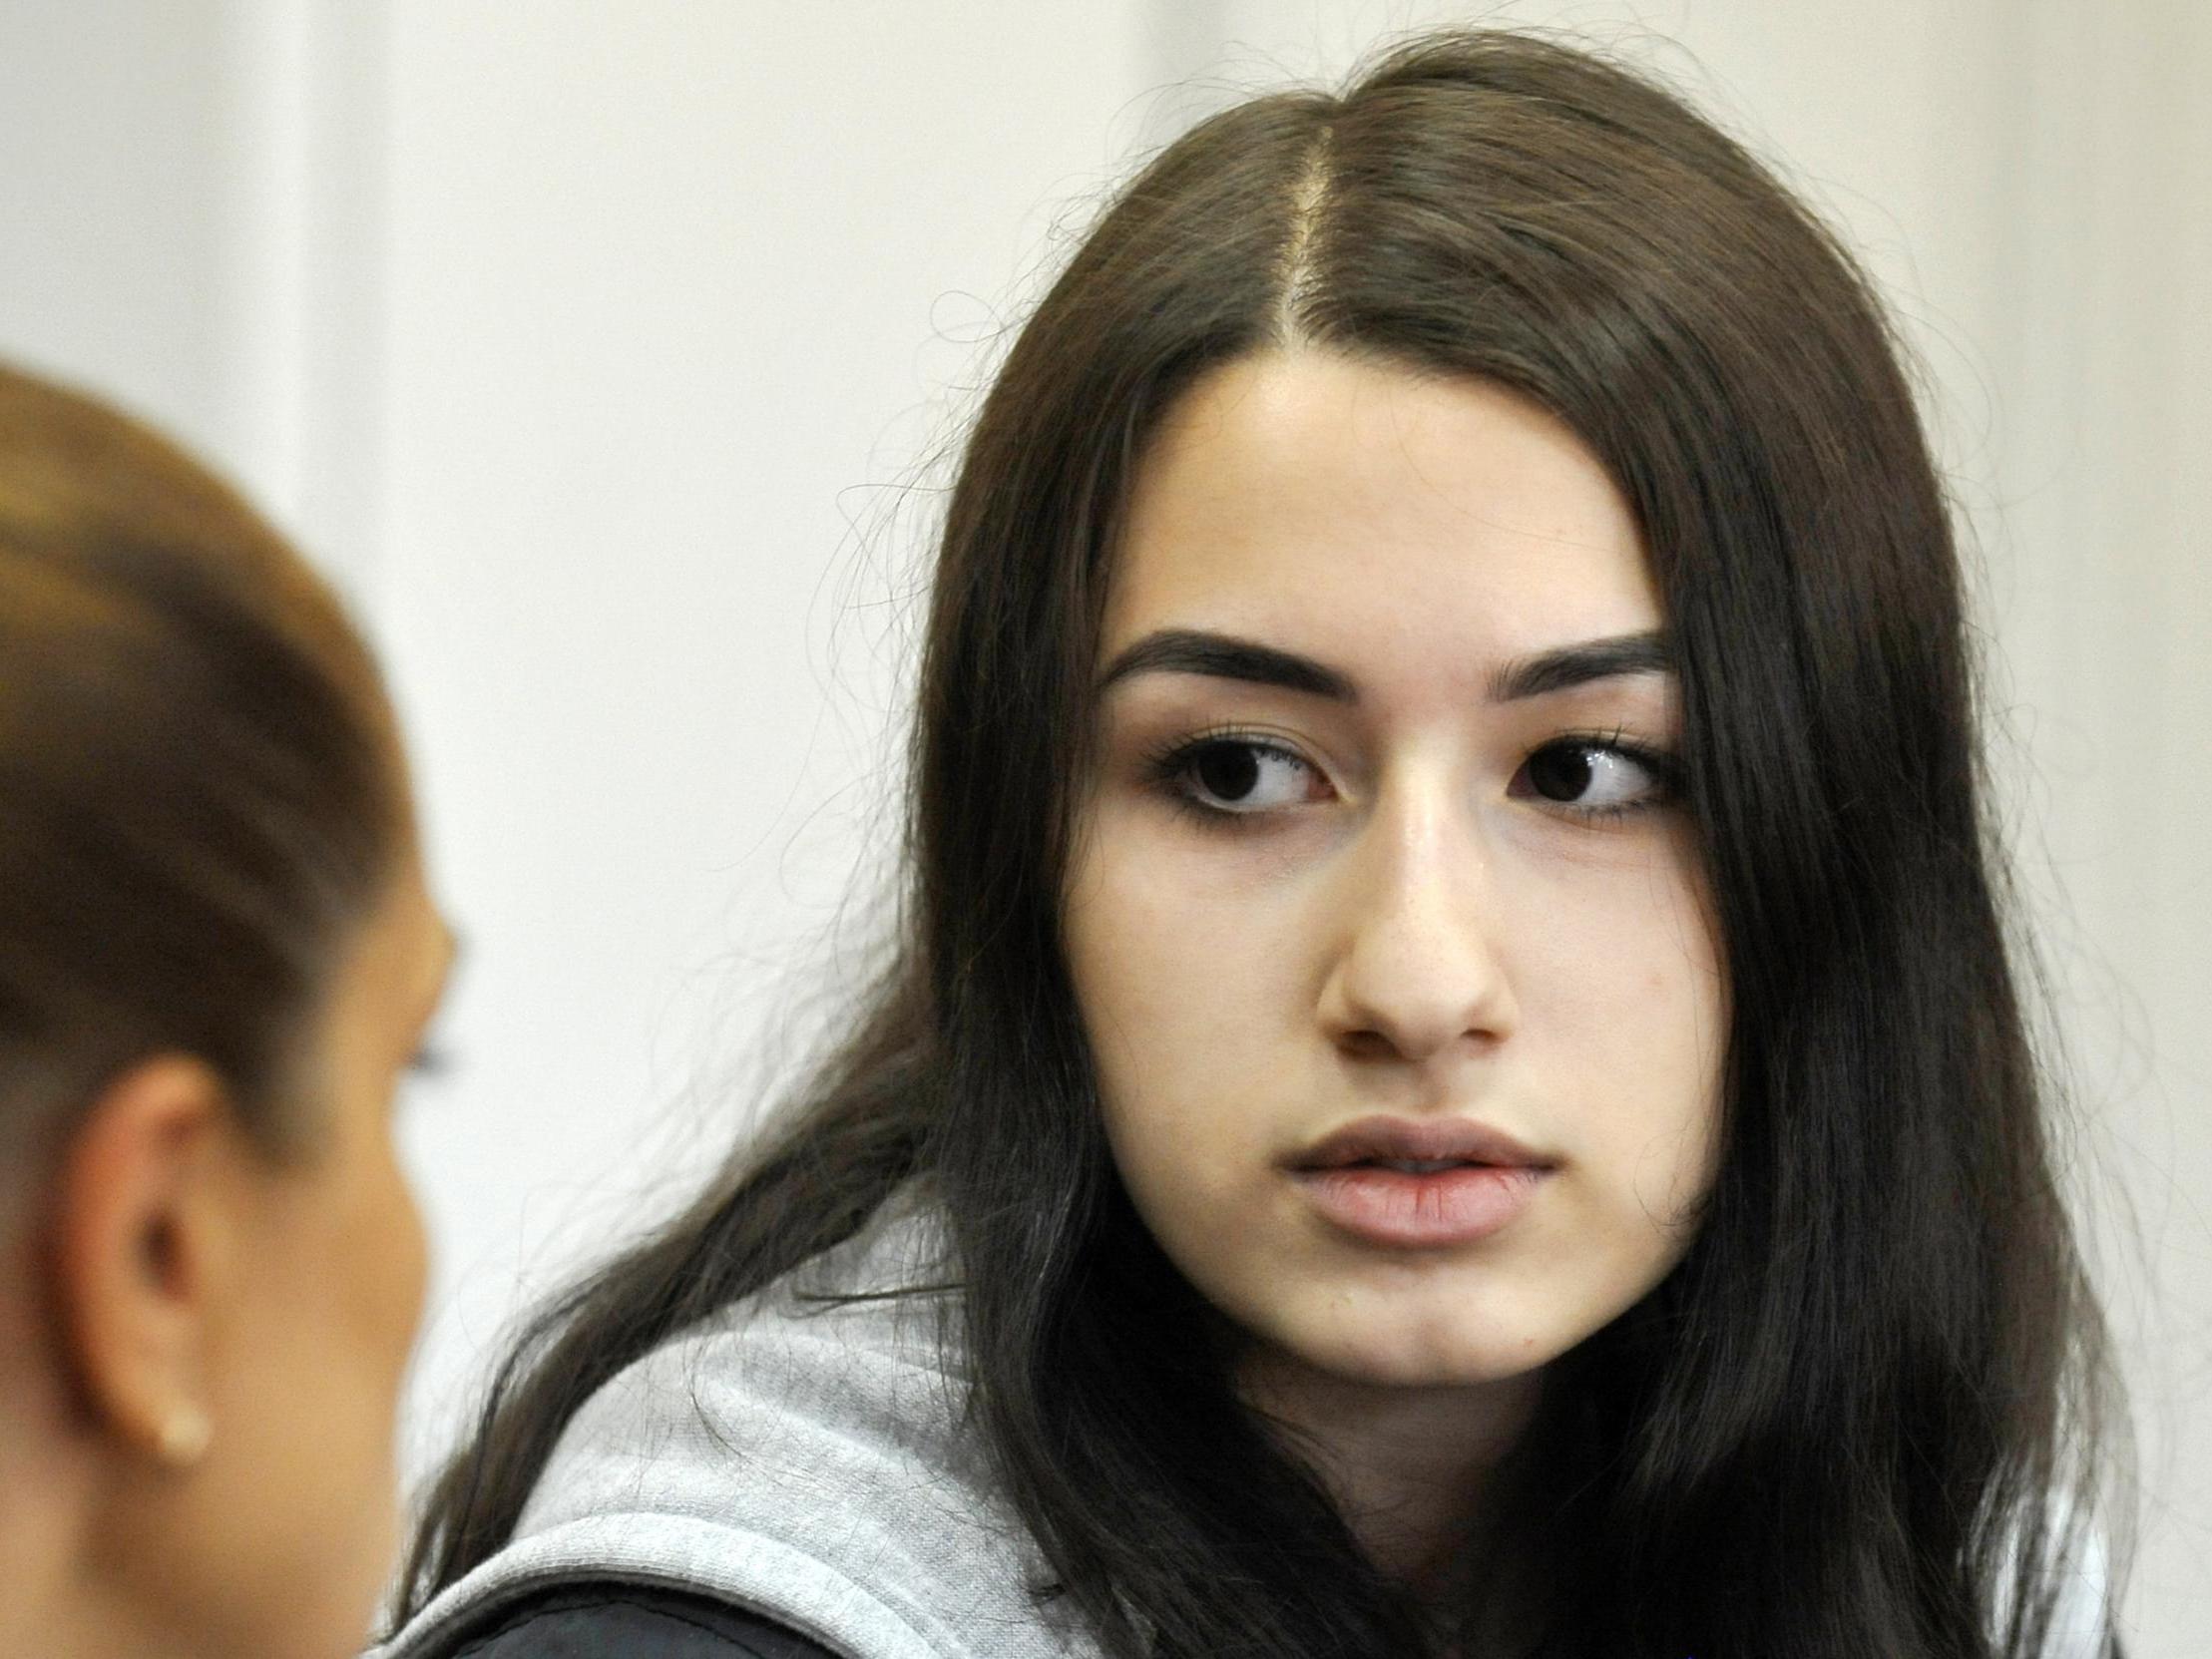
1102,352,1663,679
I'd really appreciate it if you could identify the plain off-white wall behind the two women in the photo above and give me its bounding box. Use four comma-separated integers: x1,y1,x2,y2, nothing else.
0,0,2212,1659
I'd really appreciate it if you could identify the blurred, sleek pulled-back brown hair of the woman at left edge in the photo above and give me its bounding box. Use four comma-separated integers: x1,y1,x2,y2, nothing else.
0,367,405,1203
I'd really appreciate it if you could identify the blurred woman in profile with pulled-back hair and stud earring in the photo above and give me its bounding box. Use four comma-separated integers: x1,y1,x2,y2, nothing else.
0,369,451,1659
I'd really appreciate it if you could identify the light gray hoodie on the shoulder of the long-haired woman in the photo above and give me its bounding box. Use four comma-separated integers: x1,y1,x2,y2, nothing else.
374,1199,1114,1659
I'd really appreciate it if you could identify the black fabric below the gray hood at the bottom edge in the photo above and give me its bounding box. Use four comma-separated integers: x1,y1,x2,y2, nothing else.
451,1579,836,1659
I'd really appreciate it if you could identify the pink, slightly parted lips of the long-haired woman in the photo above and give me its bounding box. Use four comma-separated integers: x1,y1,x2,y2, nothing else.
1287,1117,1552,1250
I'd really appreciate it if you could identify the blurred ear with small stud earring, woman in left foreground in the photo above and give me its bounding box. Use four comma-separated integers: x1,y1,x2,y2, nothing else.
51,1055,238,1464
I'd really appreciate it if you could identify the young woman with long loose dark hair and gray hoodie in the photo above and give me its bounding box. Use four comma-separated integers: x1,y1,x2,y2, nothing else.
389,33,2108,1659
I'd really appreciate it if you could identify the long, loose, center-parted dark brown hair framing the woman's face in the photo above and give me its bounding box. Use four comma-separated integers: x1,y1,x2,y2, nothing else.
407,33,2106,1659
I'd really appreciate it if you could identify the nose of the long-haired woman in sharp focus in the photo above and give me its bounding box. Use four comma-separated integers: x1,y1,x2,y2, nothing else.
1318,787,1518,1064
